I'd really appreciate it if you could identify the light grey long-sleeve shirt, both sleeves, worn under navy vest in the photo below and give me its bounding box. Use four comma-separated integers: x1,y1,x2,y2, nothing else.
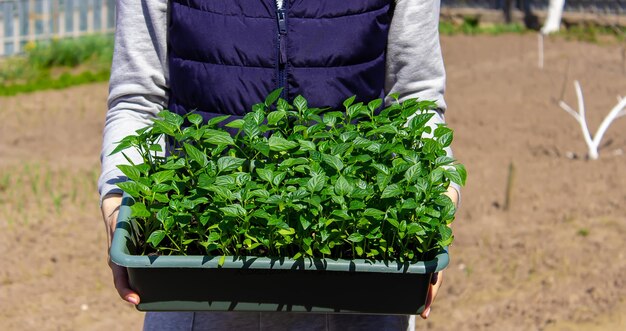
98,0,451,197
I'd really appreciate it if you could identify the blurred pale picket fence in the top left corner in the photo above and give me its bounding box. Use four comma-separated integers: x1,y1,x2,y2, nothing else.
0,0,114,57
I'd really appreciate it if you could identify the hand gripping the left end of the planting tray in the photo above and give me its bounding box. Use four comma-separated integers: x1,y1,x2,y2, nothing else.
102,194,139,305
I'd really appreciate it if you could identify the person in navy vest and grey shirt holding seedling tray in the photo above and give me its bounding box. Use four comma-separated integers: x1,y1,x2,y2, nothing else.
98,0,459,330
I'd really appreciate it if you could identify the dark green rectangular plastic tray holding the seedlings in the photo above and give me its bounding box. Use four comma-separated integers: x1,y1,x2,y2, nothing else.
110,197,448,314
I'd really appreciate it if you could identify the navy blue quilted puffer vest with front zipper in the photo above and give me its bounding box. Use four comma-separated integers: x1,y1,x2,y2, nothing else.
168,0,393,118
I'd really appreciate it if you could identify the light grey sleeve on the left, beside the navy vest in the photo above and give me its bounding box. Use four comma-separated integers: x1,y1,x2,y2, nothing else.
98,0,168,202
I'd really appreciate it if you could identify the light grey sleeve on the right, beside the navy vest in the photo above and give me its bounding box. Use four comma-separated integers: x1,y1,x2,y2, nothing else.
385,0,460,200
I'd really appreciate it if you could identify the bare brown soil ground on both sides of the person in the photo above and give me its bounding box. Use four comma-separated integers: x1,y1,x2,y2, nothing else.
0,35,626,330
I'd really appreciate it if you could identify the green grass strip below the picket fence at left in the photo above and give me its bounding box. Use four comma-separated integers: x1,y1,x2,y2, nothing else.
0,34,113,96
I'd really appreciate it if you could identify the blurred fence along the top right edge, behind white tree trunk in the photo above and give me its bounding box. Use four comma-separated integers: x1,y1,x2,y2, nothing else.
441,0,626,15
